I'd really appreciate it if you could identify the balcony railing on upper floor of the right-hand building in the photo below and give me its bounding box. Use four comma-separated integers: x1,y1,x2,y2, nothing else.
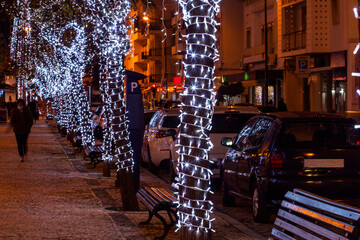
282,31,306,52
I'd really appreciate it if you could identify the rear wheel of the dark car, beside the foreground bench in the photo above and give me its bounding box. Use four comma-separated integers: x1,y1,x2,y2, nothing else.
252,185,271,223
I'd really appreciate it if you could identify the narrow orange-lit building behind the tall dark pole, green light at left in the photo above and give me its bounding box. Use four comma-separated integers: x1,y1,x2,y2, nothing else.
242,0,283,104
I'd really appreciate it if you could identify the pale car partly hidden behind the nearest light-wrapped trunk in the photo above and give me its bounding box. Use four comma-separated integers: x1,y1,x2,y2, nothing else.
170,106,260,181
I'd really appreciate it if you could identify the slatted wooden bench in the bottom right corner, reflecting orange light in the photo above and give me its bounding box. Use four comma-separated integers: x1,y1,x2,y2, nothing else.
269,189,360,240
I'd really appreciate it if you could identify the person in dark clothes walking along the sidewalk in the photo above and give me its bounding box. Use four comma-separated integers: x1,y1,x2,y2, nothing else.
10,99,33,162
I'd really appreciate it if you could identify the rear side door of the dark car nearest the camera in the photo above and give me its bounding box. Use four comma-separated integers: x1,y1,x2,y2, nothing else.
236,118,272,195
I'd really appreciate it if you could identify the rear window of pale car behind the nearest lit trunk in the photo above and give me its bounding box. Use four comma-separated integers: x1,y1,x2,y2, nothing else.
210,113,255,133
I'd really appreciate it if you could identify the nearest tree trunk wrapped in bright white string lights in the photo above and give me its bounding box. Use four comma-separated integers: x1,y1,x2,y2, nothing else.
177,0,219,239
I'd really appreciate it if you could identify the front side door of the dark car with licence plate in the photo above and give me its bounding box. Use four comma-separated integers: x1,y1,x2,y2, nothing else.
223,119,257,192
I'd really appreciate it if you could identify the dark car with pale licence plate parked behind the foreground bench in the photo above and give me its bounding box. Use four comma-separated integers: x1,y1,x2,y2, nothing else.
221,112,360,222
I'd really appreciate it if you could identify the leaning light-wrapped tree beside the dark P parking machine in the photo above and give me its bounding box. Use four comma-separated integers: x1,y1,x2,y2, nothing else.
87,0,139,210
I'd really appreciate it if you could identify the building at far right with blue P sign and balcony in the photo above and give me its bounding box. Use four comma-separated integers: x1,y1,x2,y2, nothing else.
277,0,359,113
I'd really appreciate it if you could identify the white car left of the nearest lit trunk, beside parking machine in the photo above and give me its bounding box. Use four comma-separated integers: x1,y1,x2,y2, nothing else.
141,109,180,171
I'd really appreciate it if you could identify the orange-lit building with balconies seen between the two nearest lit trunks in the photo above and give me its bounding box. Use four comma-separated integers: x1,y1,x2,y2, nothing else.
125,1,185,107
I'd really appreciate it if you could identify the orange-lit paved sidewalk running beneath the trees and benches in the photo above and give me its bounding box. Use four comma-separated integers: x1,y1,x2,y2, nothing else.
0,121,262,239
